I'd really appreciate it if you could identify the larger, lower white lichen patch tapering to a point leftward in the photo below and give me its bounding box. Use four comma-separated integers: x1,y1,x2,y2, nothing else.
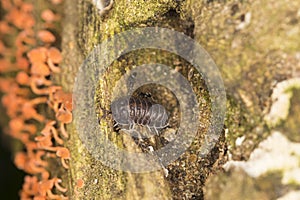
223,132,300,185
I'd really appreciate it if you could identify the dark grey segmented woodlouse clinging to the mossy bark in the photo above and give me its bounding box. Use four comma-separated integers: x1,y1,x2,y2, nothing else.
111,96,168,134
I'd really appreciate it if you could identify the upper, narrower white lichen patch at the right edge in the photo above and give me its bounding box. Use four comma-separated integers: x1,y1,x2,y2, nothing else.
264,78,300,127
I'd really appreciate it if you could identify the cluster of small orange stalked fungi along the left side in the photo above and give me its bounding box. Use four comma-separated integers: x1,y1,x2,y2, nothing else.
0,0,72,200
